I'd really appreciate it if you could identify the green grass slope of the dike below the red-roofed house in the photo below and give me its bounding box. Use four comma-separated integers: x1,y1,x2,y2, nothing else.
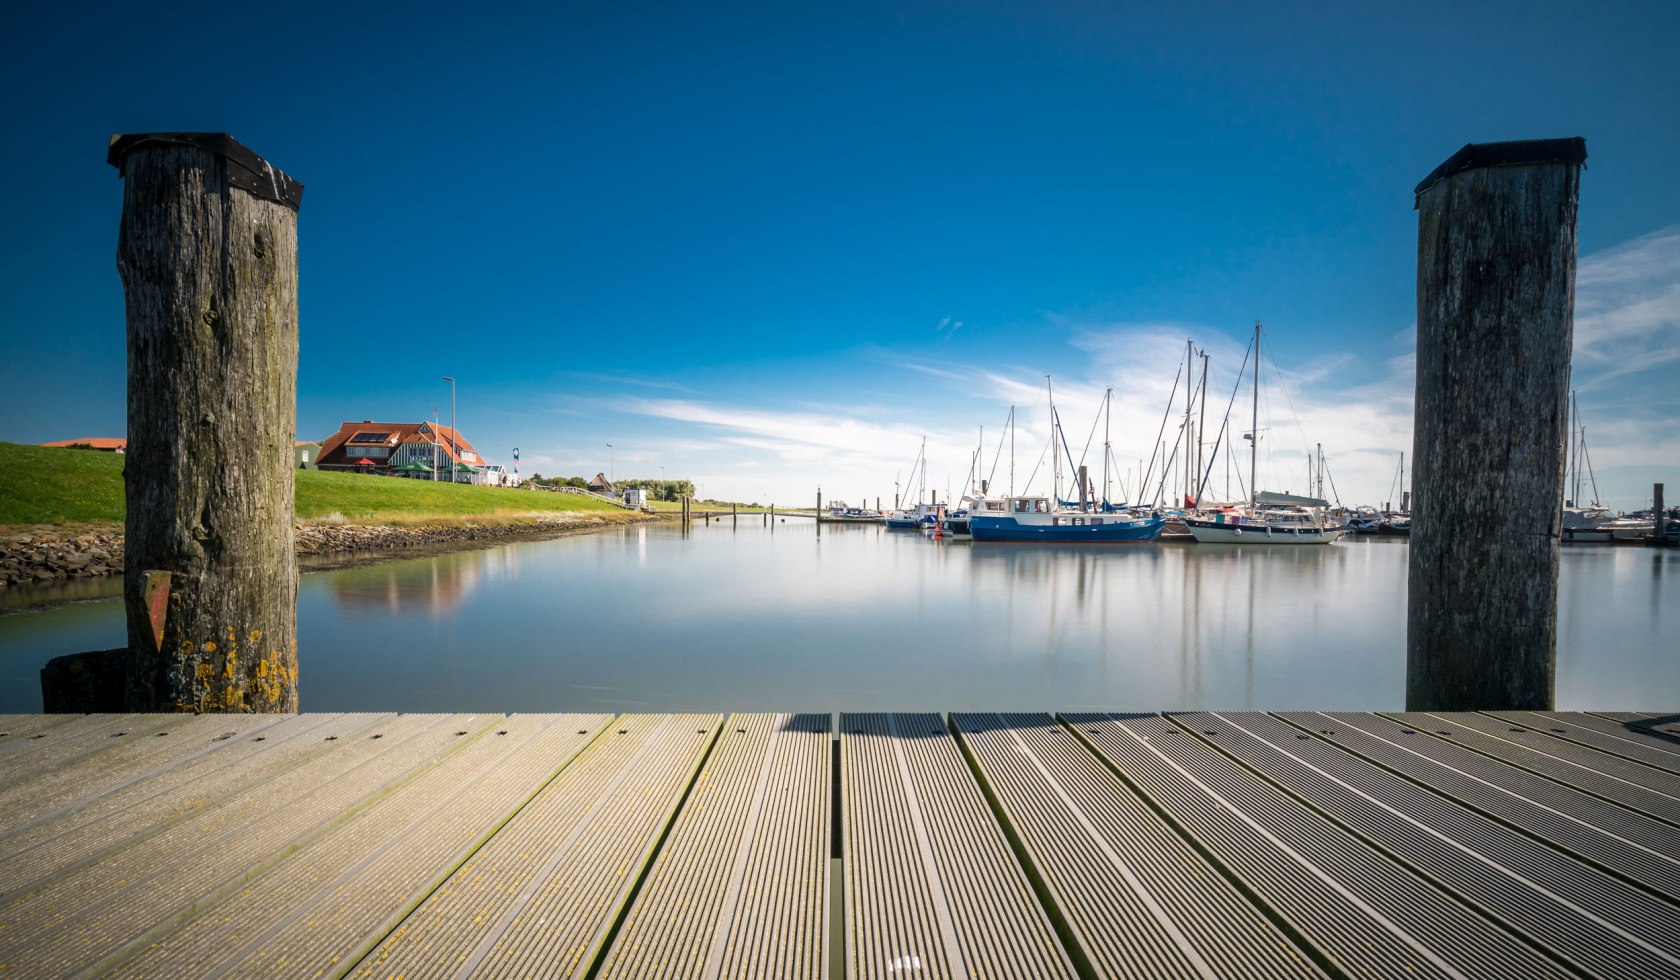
0,442,632,526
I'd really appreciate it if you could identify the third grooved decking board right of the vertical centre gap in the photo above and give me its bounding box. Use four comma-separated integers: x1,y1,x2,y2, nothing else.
1067,714,1569,978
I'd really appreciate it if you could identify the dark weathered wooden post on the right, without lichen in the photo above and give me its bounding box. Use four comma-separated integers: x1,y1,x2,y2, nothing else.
1406,138,1586,711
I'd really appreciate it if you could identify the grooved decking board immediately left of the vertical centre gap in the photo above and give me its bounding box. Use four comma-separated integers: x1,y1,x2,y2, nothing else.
598,714,833,980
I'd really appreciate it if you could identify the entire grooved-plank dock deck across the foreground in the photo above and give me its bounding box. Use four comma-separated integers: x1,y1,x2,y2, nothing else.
0,713,1680,980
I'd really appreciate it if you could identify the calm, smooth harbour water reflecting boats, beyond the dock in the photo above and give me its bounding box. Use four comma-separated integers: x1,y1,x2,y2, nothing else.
0,516,1680,711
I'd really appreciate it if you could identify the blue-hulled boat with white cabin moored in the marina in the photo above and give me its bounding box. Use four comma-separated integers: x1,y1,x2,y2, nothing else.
968,378,1166,545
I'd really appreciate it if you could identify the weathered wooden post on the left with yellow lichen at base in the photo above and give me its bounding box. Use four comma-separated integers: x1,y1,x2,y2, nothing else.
109,133,302,711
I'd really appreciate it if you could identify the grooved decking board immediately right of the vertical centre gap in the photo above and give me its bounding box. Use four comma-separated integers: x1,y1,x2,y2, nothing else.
840,714,1074,980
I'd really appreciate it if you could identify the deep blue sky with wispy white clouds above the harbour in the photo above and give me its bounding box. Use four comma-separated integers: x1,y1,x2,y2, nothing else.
0,2,1680,509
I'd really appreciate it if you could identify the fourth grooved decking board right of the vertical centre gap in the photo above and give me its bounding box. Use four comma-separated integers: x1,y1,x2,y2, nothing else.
1202,713,1680,977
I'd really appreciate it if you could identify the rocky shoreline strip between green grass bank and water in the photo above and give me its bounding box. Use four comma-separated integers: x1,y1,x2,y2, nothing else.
0,516,664,588
